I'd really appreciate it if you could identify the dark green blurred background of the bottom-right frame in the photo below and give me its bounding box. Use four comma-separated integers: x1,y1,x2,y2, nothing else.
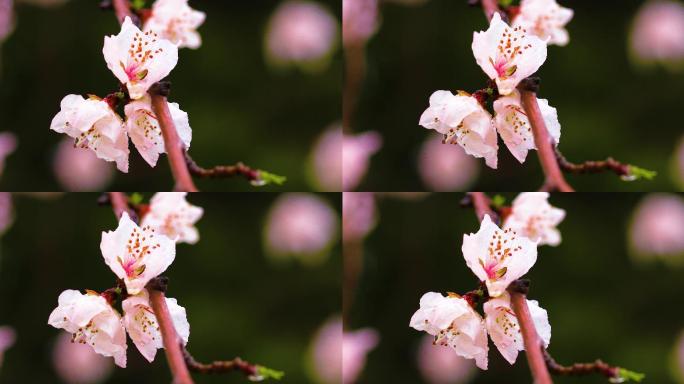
348,193,684,384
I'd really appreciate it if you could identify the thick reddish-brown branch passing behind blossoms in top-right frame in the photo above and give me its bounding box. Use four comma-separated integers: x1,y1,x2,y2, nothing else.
480,0,574,192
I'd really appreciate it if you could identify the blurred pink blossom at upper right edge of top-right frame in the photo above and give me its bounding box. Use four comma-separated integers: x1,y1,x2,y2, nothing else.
630,0,684,65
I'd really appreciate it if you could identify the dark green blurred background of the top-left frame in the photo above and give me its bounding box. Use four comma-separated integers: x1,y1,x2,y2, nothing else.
0,0,342,191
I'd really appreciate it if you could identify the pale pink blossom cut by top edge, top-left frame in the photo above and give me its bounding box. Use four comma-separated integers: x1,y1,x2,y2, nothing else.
143,0,206,49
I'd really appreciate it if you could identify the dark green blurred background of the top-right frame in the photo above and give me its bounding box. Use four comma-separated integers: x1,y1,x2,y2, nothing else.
352,0,684,191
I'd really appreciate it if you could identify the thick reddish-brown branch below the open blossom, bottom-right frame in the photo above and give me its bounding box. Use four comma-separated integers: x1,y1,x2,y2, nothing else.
508,280,553,384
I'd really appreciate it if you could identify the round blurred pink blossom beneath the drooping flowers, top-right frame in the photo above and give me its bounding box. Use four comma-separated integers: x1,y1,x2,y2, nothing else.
418,136,479,192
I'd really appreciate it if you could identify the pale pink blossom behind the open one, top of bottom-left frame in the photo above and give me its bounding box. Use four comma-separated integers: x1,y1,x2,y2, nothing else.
142,192,204,244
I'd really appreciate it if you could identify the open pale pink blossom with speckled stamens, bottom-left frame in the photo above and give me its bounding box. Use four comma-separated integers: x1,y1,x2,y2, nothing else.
100,212,176,295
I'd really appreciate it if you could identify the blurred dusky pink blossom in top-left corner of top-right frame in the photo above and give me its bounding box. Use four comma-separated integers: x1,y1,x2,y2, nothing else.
342,0,379,45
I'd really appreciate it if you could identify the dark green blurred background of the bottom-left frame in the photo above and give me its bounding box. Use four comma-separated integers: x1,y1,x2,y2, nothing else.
0,193,341,383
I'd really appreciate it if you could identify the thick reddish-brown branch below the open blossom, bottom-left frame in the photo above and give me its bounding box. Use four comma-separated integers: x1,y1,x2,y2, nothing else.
147,277,193,384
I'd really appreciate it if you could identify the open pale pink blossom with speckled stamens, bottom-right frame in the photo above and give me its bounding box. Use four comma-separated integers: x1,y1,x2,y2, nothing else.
462,215,537,297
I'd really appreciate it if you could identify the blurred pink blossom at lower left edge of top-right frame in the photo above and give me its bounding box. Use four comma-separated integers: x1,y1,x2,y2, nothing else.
342,131,382,191
